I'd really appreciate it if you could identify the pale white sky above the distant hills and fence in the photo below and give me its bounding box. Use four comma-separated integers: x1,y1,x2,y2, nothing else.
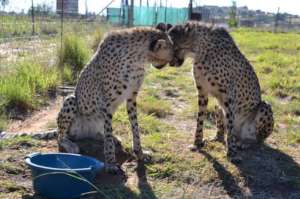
2,0,300,15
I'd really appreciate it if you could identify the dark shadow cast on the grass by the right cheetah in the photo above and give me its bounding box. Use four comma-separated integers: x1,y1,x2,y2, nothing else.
200,144,300,199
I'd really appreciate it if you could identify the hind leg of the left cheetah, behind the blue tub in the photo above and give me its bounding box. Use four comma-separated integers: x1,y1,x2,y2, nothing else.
57,96,80,153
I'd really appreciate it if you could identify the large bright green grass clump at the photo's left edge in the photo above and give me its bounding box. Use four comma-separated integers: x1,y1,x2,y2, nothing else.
0,61,59,109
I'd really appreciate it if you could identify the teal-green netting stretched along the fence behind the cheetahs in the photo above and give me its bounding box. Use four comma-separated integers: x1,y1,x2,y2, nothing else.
107,6,188,26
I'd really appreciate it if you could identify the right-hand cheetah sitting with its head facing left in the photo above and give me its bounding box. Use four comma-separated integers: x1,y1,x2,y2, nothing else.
168,22,274,163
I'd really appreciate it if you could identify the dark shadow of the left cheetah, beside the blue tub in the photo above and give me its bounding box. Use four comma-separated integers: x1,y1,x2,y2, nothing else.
77,137,157,199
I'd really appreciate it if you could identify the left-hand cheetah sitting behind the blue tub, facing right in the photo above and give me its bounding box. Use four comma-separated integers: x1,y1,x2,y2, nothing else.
57,27,173,172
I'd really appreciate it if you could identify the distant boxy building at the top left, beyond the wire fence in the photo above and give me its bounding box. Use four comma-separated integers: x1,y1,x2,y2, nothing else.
56,0,78,15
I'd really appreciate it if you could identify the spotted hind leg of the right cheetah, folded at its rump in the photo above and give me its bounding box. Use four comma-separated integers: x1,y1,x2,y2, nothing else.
255,101,274,143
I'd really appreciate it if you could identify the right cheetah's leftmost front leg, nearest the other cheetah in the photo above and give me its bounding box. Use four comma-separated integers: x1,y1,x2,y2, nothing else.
189,85,208,151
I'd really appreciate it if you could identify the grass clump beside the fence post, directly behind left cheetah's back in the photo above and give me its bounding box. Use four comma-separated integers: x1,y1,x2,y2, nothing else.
59,35,89,77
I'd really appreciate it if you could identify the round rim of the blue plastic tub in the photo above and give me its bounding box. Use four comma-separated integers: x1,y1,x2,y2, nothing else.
25,153,104,171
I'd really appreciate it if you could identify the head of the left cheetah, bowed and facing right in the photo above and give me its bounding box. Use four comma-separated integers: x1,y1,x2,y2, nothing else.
149,23,174,69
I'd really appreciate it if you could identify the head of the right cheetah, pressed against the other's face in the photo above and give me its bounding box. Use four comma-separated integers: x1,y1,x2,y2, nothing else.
168,23,194,67
